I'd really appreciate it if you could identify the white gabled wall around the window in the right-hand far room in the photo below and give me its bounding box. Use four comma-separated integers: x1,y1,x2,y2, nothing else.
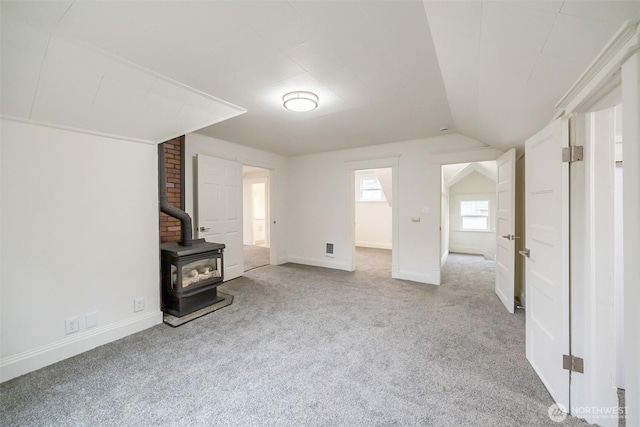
449,171,496,260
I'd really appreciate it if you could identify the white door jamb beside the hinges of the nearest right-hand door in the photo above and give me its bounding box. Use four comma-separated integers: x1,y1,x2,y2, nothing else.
570,102,618,426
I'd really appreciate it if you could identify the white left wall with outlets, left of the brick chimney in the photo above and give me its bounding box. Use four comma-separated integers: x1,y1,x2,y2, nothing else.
0,120,162,381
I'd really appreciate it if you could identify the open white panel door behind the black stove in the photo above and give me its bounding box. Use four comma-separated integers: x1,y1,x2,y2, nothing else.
196,154,244,281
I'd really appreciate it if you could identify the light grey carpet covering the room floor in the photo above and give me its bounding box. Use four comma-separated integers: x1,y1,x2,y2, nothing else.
0,250,587,426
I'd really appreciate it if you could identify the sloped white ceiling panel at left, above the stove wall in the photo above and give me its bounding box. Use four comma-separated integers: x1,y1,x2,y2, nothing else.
0,8,245,144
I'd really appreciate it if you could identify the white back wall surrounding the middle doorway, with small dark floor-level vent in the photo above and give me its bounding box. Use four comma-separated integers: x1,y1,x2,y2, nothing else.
287,135,499,284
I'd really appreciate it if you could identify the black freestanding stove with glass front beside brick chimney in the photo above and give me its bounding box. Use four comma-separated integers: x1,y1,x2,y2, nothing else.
160,239,225,317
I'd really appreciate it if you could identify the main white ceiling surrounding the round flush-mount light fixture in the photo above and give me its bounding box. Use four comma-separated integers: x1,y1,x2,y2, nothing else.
1,0,640,155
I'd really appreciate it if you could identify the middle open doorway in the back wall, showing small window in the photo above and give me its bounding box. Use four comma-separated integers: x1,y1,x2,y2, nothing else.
354,167,393,276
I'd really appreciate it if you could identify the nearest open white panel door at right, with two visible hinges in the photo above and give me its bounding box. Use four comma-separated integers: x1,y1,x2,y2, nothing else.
524,119,569,410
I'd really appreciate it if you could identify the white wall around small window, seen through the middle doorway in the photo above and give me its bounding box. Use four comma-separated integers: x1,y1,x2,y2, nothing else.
355,168,393,249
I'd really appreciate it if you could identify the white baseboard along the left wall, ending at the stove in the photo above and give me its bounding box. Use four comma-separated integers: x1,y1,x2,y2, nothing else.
0,310,162,382
